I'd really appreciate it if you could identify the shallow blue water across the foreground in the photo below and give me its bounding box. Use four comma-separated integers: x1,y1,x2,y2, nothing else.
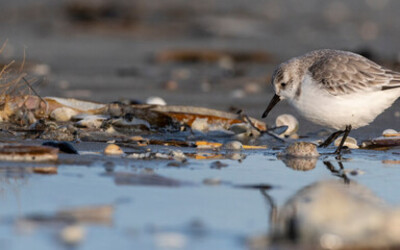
0,147,400,249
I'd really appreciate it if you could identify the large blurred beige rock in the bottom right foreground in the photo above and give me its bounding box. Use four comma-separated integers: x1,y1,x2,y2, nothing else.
271,180,400,249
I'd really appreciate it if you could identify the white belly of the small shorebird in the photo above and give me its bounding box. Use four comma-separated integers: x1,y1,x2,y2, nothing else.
291,84,400,130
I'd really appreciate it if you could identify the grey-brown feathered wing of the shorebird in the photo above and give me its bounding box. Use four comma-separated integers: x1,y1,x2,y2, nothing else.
308,52,400,95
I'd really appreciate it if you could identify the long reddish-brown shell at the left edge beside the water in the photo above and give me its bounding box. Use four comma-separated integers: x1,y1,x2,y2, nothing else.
0,144,59,162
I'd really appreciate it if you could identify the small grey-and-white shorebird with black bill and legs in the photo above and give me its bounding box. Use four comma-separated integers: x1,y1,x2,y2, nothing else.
262,49,400,154
